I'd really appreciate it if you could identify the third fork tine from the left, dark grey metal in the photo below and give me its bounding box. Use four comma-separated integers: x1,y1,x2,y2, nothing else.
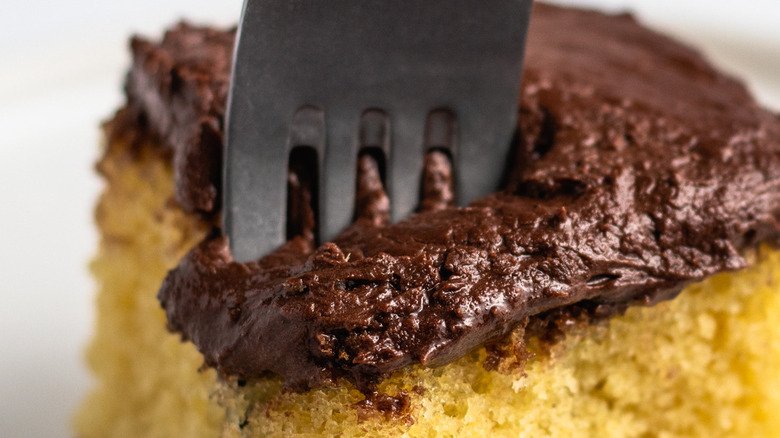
387,108,427,222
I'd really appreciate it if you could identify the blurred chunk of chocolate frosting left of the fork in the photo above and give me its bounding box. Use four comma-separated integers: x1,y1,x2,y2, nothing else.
125,23,235,213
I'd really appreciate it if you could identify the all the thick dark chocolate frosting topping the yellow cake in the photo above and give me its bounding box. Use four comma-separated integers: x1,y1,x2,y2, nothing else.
120,4,780,390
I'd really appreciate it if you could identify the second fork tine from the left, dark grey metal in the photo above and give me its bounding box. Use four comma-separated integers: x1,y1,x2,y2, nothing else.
320,107,360,241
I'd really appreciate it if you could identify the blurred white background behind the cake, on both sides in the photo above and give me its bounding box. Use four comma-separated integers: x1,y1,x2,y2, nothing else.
0,0,780,437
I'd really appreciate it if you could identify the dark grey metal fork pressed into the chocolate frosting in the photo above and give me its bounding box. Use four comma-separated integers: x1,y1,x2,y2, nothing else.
223,0,532,262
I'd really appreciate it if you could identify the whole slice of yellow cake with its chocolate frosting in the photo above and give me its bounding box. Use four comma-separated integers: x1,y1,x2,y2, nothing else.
76,4,780,438
